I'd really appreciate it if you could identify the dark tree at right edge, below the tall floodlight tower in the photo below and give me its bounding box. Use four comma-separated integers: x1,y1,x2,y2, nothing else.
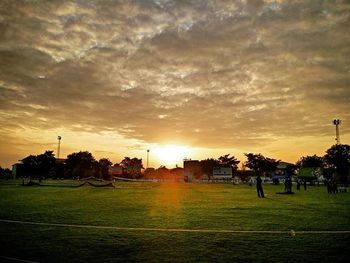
324,144,350,185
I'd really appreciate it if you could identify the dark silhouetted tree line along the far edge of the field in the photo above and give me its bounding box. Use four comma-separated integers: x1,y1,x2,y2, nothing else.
0,144,350,183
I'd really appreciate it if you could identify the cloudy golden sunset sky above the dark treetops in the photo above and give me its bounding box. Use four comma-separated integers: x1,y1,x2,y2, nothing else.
0,0,350,167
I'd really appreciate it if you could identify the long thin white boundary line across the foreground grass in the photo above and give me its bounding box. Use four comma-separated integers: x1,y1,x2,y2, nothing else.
0,219,350,235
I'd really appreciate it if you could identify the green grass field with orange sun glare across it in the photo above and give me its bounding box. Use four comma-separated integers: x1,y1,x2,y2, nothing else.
0,182,350,262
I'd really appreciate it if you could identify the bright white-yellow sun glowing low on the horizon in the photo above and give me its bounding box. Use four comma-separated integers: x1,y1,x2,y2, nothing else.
152,145,190,166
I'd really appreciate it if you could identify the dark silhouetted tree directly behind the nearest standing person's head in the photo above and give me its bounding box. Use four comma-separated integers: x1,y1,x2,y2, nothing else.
244,153,279,176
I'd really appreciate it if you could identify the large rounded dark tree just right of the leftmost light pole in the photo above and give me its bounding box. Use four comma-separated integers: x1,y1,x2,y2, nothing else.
66,151,96,178
